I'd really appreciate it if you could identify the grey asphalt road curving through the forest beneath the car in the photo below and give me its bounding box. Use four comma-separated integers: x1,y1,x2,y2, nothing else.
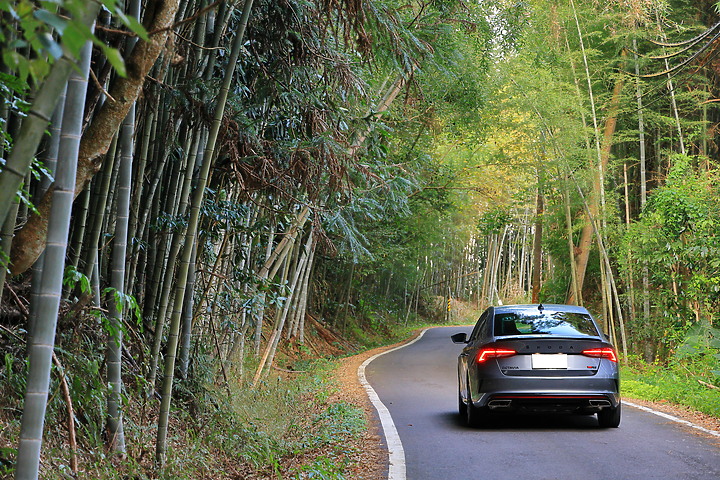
365,327,720,480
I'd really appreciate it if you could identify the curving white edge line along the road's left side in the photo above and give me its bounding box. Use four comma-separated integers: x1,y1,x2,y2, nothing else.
358,328,428,480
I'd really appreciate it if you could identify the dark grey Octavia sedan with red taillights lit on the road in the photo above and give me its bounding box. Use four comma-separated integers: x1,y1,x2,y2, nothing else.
452,305,621,428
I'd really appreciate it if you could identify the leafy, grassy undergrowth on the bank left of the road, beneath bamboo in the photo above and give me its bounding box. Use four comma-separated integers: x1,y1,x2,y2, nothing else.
0,296,444,480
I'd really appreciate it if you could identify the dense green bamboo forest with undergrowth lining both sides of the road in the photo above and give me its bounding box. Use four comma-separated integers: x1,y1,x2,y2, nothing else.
0,0,720,479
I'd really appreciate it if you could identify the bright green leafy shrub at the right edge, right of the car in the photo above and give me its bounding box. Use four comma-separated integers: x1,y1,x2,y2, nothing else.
619,155,720,353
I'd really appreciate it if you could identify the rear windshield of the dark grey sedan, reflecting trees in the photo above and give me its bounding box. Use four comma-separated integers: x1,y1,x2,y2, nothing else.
494,310,598,337
